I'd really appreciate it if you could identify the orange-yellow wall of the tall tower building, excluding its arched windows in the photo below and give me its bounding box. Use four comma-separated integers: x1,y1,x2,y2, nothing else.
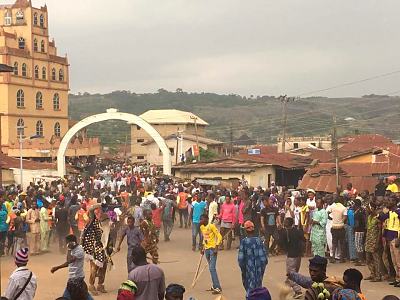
0,3,76,157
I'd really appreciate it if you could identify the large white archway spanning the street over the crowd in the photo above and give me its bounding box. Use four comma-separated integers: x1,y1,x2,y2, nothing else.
57,108,171,177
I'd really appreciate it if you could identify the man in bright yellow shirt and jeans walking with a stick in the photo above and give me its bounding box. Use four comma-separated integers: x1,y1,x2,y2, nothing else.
200,214,222,295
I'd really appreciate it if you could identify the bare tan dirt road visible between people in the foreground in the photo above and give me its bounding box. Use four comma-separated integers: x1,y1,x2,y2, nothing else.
1,229,400,300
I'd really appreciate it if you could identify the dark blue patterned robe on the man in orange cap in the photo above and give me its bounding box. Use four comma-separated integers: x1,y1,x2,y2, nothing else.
238,237,268,292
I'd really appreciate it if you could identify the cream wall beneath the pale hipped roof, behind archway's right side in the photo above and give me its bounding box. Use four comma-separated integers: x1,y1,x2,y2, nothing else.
131,124,205,161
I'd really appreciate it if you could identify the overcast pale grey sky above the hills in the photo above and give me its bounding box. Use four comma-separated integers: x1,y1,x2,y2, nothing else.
19,0,400,96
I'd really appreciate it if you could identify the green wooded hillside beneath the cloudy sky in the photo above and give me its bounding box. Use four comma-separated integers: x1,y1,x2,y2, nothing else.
69,89,400,145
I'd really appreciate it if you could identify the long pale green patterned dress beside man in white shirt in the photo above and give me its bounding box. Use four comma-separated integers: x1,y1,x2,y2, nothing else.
310,209,328,257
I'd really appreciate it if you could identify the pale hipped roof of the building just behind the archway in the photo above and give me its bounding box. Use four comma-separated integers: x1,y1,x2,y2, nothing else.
140,109,209,126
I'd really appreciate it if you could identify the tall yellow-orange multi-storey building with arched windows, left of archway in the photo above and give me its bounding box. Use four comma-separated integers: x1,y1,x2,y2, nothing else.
0,0,100,158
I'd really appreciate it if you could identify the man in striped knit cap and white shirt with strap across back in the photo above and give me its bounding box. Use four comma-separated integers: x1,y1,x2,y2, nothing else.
4,248,37,300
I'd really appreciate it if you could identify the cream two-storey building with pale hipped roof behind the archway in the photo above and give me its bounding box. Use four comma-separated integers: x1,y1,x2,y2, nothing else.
131,109,212,164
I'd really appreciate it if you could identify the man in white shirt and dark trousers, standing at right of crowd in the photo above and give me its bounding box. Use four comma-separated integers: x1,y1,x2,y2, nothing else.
326,197,347,263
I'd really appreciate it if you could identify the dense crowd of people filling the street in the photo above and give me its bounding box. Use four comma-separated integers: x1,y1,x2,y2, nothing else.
0,163,400,300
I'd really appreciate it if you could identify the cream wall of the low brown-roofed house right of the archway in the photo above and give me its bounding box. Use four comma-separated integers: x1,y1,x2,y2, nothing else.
175,166,275,188
